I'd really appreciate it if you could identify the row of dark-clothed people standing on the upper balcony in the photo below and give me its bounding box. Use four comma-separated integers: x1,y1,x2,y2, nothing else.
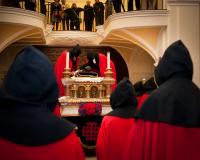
2,0,157,31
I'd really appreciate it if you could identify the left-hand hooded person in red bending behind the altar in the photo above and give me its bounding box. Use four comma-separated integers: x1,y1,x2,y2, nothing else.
54,44,81,116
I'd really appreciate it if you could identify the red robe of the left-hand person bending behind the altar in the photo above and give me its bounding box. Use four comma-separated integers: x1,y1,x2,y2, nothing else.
54,51,80,97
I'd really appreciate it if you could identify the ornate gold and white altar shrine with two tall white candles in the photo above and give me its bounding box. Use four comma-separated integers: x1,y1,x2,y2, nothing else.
59,52,115,117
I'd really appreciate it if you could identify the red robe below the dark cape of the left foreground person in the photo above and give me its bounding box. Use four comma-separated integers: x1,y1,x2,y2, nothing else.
0,132,85,160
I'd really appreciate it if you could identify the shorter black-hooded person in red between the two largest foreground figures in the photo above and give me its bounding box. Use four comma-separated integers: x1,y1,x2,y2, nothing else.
96,79,137,160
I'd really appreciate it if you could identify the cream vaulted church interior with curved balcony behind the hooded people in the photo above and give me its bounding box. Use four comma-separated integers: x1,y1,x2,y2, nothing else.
0,0,200,159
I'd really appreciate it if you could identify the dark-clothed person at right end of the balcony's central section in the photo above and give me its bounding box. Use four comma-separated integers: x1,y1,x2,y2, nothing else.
93,0,105,26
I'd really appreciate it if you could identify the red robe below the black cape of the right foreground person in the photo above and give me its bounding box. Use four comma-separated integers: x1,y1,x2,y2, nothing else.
124,119,200,160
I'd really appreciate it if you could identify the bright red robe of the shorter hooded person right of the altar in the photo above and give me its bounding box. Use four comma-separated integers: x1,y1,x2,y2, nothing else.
96,116,134,160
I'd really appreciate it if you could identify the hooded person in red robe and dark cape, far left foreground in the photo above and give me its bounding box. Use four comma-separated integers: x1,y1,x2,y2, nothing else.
0,47,85,160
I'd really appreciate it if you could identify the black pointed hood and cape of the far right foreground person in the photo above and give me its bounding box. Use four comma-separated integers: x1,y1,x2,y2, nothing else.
135,41,200,127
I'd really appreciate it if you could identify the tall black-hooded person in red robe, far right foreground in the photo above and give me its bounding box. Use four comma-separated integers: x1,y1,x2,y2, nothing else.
124,40,200,160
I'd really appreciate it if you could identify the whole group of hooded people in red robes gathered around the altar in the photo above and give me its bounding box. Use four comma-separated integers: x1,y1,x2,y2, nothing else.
0,40,200,160
